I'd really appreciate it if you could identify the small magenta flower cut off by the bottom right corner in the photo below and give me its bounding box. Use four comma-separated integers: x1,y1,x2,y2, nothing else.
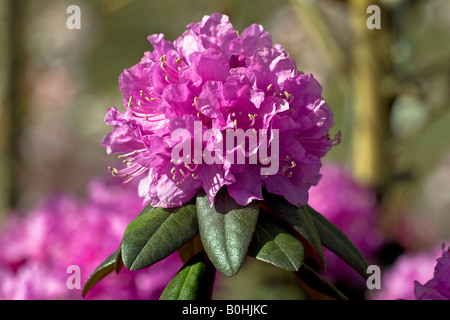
414,249,450,300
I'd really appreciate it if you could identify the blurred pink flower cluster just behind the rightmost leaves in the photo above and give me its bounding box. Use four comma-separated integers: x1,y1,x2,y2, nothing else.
308,163,383,286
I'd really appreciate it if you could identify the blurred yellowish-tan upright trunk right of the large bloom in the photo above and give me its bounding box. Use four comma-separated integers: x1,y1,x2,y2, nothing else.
349,0,389,189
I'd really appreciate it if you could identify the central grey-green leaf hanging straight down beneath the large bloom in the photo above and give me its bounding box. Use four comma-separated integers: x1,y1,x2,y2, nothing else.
197,188,259,276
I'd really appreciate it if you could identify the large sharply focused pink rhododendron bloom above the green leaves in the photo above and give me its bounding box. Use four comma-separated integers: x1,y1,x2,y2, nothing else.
102,13,339,207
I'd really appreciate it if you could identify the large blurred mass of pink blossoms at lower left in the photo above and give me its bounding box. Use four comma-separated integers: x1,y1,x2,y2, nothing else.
0,180,182,300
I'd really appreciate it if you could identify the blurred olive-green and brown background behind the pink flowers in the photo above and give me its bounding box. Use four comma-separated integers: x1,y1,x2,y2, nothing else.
0,0,450,299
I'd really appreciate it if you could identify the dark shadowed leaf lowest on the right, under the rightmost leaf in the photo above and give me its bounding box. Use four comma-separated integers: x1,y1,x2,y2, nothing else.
295,264,348,300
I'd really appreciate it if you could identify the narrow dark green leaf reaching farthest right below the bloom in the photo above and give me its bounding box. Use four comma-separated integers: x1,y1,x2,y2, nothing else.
310,205,368,278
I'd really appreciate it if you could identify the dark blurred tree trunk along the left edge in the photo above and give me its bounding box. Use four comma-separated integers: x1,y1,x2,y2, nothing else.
0,0,28,216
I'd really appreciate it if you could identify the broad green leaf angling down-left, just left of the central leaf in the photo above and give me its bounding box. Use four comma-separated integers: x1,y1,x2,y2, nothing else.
121,204,198,270
